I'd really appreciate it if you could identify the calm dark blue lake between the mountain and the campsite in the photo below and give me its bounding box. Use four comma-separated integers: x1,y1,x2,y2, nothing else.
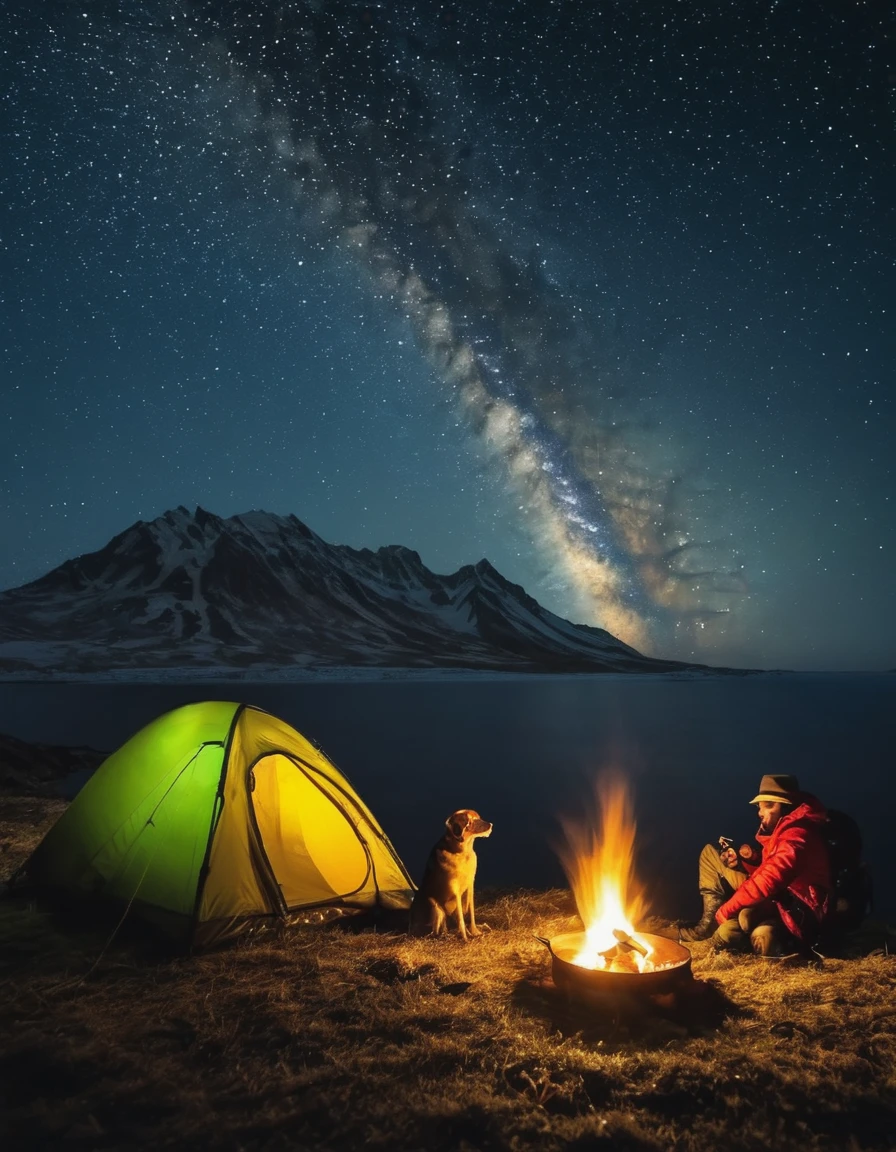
0,674,896,919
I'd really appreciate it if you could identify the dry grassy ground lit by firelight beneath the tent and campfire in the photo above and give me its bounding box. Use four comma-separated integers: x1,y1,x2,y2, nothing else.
0,797,896,1152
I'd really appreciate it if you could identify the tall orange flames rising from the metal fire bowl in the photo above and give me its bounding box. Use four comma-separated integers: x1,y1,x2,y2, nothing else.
550,773,653,971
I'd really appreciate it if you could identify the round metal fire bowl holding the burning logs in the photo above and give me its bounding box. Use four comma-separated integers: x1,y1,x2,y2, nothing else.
536,932,693,996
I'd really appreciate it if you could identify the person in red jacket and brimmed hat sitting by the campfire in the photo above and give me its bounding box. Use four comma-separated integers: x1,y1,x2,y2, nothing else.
679,775,833,956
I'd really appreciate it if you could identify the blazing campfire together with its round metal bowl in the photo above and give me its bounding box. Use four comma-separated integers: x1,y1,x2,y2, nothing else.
544,775,691,991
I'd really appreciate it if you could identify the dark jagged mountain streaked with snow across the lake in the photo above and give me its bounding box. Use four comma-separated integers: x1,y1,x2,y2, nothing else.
0,508,689,674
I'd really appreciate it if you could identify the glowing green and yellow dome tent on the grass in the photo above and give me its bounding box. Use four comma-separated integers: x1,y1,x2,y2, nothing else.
23,702,413,947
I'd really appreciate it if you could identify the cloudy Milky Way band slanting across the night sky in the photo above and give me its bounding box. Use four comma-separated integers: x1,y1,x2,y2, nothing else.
178,3,745,649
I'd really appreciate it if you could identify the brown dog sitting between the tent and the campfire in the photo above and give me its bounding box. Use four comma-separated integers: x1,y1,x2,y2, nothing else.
410,808,492,940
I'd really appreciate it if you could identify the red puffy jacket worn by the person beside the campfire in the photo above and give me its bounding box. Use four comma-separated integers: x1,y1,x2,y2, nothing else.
715,793,833,943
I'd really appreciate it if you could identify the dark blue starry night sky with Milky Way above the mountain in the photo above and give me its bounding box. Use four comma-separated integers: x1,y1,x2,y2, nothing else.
0,0,896,670
